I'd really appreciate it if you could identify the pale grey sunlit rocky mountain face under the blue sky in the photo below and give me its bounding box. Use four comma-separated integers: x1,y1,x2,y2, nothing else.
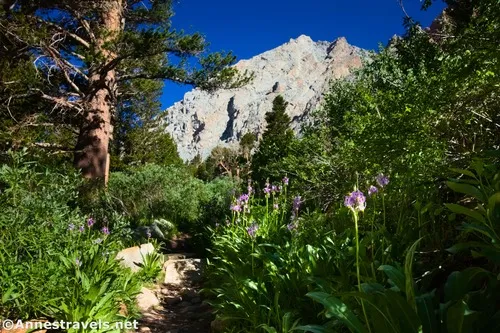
163,35,364,160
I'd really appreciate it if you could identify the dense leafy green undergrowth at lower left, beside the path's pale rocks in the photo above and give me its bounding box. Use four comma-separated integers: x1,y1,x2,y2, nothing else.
0,153,140,322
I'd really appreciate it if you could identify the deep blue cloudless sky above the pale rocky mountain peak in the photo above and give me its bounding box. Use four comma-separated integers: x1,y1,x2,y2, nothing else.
161,0,443,108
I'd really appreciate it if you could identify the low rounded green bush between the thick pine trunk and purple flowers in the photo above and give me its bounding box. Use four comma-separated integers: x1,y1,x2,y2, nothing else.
107,164,235,231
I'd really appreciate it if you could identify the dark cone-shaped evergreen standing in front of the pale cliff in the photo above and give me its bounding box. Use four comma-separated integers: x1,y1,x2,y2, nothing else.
252,96,294,183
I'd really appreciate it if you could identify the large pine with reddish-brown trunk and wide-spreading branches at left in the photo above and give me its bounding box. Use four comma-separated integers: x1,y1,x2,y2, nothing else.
0,0,249,182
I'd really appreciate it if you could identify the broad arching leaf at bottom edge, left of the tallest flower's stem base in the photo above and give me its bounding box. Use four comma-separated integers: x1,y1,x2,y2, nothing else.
306,292,366,332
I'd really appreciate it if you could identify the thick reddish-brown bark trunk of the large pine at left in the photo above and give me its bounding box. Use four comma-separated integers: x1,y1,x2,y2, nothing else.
75,0,123,182
